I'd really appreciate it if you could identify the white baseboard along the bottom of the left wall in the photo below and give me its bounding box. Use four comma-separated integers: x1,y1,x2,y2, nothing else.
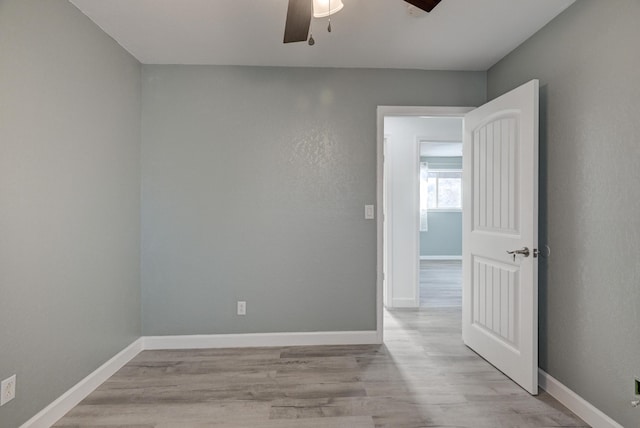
21,338,143,428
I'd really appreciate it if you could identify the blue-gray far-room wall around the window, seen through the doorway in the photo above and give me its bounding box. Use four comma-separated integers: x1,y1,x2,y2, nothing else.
420,157,462,256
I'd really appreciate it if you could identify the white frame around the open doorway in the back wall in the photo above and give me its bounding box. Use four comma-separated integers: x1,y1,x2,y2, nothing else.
376,106,475,343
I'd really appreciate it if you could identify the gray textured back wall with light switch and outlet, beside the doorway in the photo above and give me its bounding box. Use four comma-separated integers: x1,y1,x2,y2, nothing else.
142,66,486,335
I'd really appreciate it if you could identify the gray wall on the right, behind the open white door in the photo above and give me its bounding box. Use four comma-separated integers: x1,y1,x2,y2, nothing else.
488,0,640,427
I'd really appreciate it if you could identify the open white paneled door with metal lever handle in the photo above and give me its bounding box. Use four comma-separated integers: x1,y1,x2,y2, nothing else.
462,80,539,394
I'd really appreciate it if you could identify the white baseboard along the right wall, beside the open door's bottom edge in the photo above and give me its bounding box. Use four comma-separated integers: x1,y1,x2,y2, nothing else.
538,369,624,428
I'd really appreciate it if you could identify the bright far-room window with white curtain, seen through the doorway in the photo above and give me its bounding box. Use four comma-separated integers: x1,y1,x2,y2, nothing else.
420,162,462,231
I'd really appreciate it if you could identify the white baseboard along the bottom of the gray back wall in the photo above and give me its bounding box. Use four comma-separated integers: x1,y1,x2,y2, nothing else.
143,330,381,350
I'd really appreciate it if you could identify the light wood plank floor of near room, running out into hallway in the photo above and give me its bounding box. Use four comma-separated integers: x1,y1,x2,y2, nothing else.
55,262,586,428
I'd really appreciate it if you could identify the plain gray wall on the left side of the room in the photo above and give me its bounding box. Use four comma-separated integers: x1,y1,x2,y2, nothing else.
0,0,141,428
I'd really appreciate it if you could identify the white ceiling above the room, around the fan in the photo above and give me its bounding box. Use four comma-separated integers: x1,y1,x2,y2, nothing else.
70,0,575,71
